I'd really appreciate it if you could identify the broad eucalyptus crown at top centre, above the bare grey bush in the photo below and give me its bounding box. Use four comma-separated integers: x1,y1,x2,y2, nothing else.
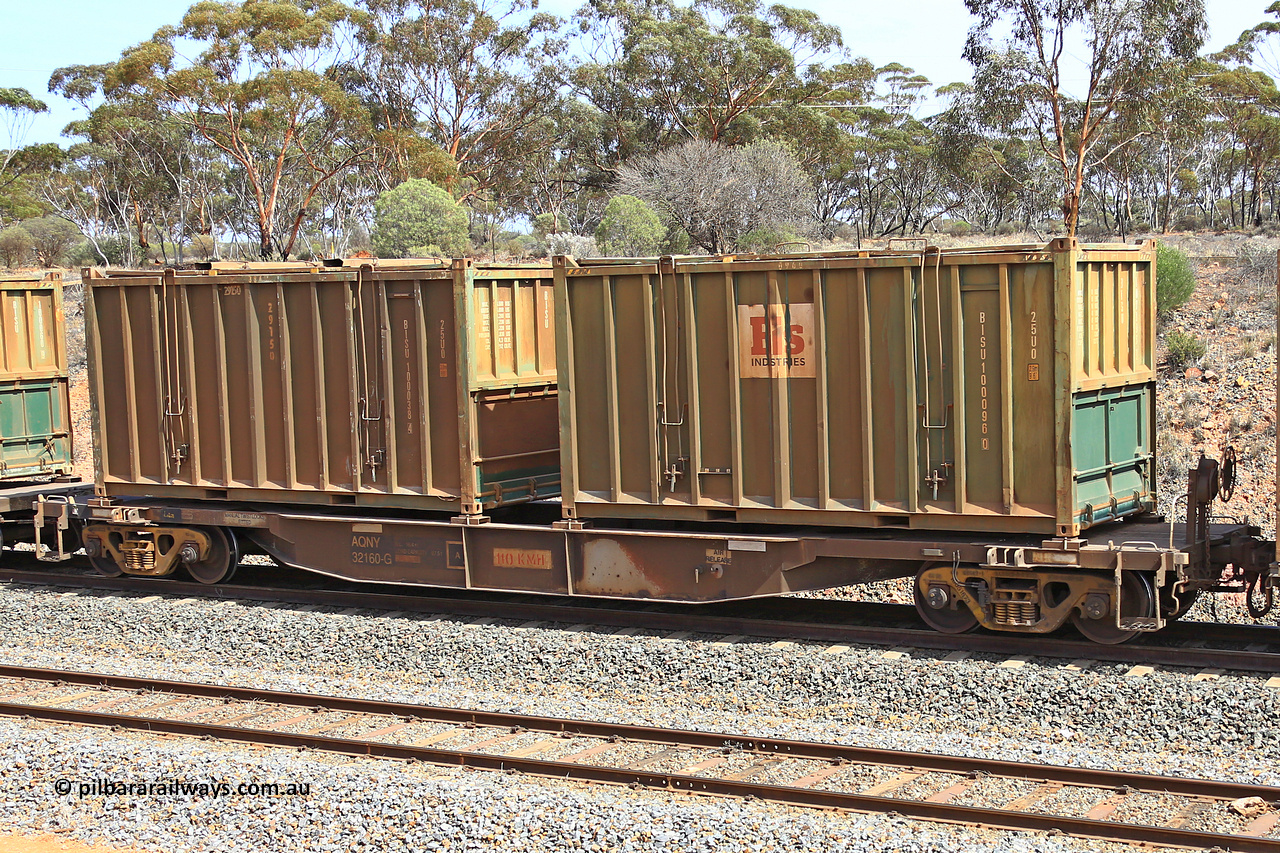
566,0,864,163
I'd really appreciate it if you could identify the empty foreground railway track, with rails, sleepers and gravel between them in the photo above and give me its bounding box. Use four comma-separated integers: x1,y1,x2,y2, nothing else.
0,666,1280,853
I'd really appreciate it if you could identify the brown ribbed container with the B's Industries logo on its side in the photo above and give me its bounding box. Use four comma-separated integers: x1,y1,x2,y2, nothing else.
556,240,1156,535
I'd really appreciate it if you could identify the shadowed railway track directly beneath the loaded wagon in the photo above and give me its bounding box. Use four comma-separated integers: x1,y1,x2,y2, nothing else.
0,561,1280,674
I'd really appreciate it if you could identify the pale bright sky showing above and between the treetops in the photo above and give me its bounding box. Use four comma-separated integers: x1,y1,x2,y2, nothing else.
0,0,1271,146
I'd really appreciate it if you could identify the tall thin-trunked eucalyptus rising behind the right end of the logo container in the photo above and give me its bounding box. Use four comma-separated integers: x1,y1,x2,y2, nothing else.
964,0,1207,236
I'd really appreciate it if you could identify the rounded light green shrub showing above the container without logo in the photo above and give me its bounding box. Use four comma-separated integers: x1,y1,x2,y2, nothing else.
372,178,470,257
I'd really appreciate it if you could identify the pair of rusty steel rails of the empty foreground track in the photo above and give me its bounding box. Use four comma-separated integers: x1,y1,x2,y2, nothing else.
0,666,1280,853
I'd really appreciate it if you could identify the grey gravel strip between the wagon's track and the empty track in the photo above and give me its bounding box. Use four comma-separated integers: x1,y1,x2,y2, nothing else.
0,588,1280,784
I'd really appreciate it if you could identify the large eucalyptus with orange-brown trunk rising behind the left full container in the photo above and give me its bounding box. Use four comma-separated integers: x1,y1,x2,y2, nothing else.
55,0,374,257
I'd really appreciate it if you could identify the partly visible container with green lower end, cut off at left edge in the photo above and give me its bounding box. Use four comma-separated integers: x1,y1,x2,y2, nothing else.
0,273,72,482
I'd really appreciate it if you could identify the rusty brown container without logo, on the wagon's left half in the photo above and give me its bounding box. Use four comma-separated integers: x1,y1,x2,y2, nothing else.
86,260,559,515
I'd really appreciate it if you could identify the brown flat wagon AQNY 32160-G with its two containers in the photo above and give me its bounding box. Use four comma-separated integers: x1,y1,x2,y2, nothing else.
37,240,1275,643
